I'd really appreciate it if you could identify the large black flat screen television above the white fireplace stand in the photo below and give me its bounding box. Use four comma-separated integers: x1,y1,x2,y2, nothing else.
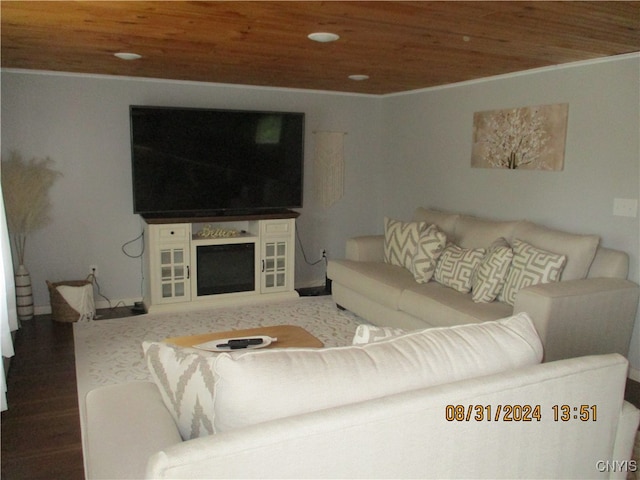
129,105,304,218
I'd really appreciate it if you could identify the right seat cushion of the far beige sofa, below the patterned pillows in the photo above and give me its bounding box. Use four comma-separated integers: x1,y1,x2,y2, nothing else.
398,282,513,327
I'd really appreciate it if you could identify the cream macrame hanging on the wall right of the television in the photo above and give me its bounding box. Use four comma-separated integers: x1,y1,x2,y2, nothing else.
313,132,346,208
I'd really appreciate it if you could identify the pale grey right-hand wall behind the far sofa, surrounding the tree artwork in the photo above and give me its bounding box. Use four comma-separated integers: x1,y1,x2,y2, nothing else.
378,55,640,376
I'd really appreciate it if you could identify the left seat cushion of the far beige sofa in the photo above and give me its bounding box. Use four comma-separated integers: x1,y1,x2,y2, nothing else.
327,260,416,310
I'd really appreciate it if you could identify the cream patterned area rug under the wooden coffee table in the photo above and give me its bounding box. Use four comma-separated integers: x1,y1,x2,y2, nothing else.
73,296,365,398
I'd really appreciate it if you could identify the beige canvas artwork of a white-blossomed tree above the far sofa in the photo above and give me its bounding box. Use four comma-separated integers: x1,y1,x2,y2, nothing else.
471,103,569,171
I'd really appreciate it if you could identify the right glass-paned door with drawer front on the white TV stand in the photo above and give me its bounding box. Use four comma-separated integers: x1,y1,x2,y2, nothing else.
261,220,294,293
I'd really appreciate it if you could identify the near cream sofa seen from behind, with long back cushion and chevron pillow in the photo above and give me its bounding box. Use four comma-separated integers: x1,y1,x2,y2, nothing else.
84,314,640,479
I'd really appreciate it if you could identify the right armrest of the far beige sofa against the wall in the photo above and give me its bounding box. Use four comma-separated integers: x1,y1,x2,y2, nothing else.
513,278,640,362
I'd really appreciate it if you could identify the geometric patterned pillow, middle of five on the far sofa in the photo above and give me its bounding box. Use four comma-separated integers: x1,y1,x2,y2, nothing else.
434,243,486,293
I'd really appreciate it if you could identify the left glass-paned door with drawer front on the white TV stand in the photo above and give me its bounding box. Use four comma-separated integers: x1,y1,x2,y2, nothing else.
153,224,191,303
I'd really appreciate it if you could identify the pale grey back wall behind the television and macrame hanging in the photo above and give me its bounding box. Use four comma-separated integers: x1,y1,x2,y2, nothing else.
2,71,381,311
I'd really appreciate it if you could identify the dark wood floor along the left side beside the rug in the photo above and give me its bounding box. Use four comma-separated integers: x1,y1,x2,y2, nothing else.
1,307,640,480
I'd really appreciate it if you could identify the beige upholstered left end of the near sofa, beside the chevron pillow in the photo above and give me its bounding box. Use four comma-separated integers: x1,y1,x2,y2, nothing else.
84,382,182,479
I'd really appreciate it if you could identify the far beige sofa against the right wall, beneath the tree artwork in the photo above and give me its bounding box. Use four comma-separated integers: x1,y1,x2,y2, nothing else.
327,208,639,361
